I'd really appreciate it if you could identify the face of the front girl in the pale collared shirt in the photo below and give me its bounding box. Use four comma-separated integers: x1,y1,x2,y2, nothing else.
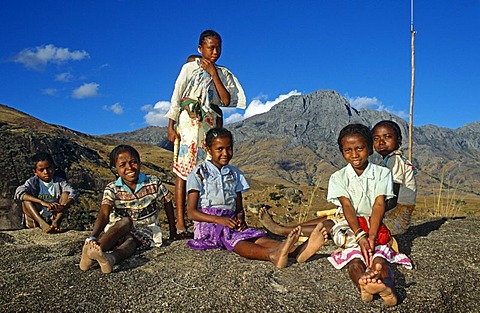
342,135,370,175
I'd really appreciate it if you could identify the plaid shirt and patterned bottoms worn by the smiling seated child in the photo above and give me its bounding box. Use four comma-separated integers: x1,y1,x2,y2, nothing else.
102,173,172,249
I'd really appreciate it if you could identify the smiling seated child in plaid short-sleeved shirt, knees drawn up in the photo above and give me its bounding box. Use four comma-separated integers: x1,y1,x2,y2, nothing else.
80,145,176,274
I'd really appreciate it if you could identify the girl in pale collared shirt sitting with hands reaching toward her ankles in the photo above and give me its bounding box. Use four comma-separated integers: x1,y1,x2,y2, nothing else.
327,124,411,306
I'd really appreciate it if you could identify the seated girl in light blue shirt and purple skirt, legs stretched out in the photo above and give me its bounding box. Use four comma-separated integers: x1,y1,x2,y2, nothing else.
187,128,327,268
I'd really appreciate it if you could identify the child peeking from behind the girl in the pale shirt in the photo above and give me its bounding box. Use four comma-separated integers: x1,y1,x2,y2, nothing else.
372,121,417,235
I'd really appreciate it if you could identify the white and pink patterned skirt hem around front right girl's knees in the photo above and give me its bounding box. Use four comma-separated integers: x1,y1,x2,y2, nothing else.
328,244,412,269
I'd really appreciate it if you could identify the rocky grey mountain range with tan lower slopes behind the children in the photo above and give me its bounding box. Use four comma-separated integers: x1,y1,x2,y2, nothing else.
110,90,480,196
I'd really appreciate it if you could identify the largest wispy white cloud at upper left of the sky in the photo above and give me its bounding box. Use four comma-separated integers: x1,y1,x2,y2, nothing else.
13,44,89,70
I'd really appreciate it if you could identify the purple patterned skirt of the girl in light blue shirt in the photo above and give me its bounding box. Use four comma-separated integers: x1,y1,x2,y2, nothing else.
187,208,265,251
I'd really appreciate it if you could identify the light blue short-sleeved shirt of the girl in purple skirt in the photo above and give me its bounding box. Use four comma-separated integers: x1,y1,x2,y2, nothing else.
187,161,250,211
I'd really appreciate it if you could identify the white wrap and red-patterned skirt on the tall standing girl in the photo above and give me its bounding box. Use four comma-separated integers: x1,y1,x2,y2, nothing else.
165,61,246,180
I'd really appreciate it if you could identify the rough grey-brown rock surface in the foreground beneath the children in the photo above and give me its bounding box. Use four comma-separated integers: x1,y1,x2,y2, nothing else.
0,217,480,312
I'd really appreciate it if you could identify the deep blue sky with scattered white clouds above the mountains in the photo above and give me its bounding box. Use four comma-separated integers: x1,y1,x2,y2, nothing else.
0,0,480,134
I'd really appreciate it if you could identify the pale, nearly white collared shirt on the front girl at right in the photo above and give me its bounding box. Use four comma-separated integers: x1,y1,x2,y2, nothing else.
327,162,395,216
